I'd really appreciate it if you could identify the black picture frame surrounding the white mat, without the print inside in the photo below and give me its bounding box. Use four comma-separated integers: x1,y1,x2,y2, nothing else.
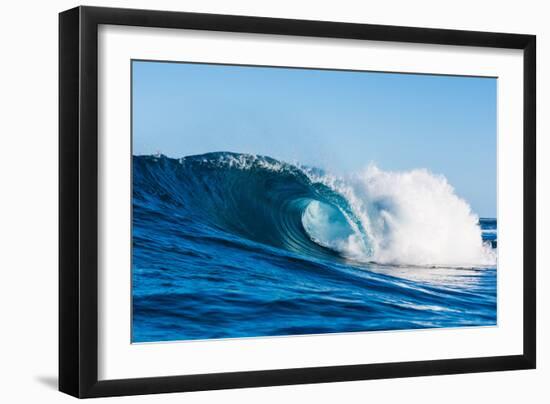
59,7,536,398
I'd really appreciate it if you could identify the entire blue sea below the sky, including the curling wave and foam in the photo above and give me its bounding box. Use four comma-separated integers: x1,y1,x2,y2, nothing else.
132,152,497,342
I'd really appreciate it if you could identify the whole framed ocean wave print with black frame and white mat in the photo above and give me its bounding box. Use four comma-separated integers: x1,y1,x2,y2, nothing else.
59,7,536,397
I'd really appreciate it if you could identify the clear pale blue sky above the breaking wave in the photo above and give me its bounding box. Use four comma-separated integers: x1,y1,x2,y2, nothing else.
132,61,497,217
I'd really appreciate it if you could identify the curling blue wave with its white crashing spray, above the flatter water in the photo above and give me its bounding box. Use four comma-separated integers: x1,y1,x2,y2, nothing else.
133,152,496,267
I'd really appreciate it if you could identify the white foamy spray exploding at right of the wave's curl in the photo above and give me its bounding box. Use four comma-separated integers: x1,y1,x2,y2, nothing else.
306,165,496,267
